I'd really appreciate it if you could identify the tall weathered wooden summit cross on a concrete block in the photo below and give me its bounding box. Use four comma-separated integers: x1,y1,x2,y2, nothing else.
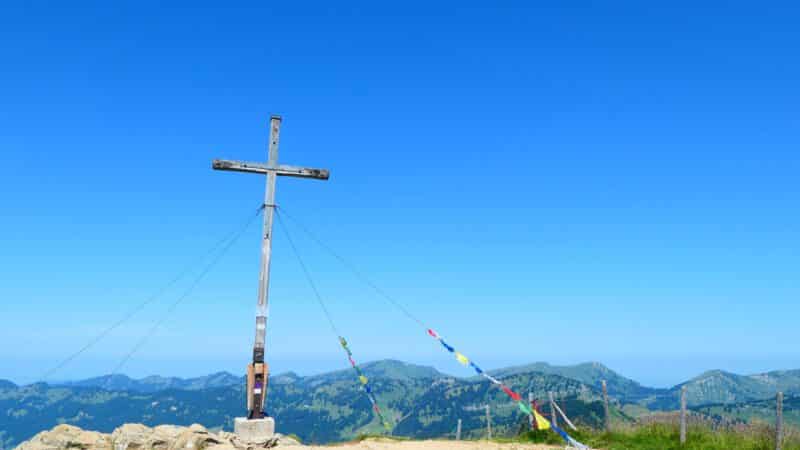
211,116,329,419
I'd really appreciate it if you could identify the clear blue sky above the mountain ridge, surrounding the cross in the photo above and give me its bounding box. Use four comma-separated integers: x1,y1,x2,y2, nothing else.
0,1,800,385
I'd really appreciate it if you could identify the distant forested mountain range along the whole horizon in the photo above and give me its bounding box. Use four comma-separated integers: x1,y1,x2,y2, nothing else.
0,360,800,450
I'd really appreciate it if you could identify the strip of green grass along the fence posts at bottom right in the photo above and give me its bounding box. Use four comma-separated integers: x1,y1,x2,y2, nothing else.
520,424,800,450
